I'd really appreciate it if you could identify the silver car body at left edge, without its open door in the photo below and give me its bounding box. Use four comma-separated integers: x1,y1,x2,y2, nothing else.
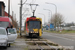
0,27,8,48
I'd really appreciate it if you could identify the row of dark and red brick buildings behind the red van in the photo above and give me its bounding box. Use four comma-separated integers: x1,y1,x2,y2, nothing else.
0,1,17,28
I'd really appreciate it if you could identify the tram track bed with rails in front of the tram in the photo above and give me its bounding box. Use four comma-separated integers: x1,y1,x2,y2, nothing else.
25,38,72,50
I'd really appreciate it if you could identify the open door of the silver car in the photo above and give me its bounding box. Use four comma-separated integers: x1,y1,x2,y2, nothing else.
7,28,17,47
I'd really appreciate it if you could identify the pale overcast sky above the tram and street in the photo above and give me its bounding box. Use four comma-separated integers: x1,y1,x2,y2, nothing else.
1,0,75,23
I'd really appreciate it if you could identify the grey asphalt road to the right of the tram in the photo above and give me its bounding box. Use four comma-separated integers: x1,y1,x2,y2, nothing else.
42,32,75,50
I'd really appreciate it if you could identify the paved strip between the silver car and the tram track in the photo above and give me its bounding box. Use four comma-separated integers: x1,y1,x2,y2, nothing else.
7,33,28,50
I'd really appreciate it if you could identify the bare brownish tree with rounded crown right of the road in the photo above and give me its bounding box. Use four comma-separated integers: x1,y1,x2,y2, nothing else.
49,13,64,27
